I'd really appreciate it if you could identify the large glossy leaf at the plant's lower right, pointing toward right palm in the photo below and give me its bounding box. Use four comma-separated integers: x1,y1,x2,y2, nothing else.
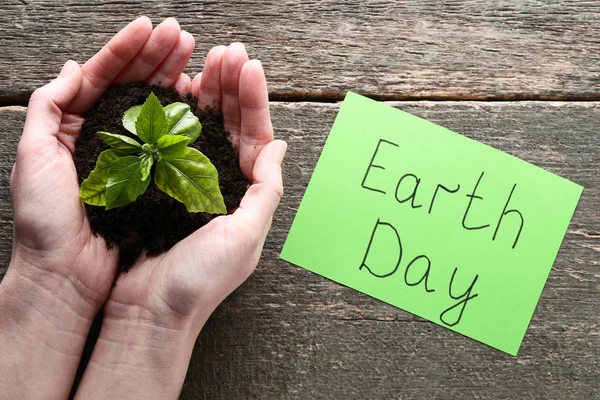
154,147,227,214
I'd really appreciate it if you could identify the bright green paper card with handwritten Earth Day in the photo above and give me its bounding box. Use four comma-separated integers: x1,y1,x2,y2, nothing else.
281,93,583,355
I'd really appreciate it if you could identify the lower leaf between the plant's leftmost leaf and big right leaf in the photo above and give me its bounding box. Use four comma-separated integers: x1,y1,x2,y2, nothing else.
106,156,150,210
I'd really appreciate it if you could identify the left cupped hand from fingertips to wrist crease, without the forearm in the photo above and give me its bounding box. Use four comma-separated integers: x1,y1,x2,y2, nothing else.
7,17,194,315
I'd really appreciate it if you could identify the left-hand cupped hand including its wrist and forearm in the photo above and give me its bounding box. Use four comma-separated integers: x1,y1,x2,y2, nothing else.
0,17,199,398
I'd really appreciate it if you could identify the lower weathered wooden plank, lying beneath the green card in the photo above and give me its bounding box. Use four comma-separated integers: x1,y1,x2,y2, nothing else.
0,102,600,399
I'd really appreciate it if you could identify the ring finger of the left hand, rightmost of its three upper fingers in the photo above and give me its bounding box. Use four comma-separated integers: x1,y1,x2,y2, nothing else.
149,31,196,88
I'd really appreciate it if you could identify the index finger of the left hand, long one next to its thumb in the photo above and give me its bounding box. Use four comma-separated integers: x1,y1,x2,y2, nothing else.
68,17,152,113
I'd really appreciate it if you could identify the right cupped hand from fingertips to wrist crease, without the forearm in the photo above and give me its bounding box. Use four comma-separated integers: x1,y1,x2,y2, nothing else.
105,43,287,334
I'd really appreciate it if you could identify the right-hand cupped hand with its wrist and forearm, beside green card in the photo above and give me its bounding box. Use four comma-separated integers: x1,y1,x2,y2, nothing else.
77,43,286,399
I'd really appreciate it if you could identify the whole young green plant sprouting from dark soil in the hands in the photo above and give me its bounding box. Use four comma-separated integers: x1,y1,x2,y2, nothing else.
79,93,227,214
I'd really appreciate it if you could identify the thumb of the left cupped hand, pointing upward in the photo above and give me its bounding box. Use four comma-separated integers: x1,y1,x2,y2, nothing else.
20,60,82,154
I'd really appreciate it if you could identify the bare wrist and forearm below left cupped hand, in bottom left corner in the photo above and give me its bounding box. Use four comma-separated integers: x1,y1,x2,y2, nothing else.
0,262,99,399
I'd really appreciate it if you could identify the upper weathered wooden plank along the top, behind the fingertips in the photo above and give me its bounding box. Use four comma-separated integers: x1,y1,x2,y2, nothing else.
0,0,600,104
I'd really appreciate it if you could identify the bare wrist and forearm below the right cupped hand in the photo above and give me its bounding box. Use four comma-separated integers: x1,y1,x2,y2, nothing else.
76,300,197,399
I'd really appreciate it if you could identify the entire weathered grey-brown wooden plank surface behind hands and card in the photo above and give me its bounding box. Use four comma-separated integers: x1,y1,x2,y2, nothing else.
0,0,600,400
